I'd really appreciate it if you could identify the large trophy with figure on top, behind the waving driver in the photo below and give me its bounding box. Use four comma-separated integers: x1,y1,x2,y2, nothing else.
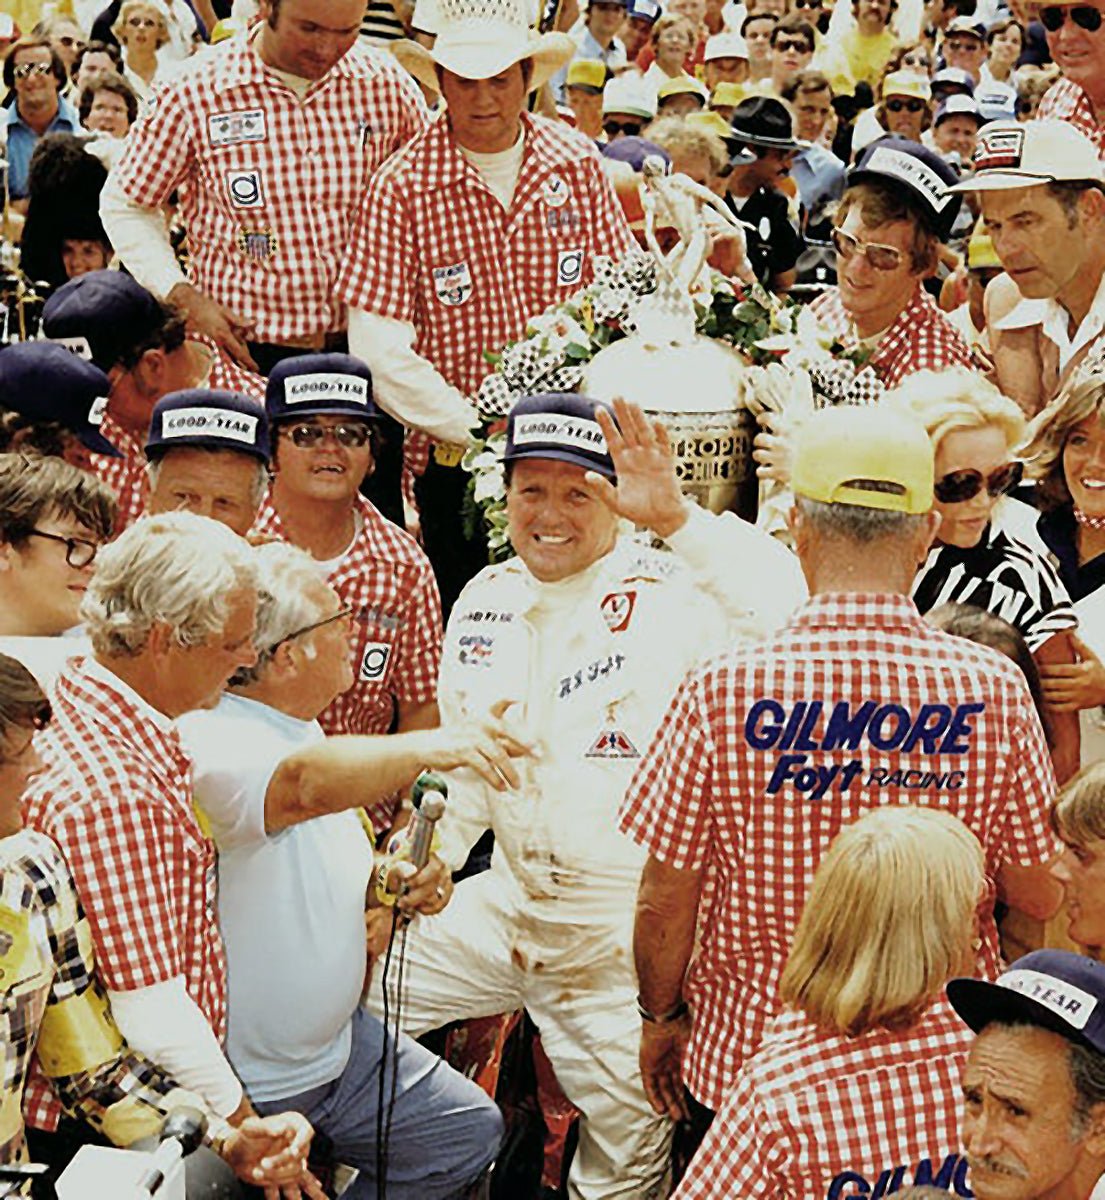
579,158,757,520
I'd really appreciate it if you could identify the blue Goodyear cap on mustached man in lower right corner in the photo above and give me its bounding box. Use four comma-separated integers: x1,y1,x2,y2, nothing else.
948,950,1105,1054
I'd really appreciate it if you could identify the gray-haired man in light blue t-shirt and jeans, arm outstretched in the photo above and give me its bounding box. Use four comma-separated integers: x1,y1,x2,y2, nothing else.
178,542,514,1200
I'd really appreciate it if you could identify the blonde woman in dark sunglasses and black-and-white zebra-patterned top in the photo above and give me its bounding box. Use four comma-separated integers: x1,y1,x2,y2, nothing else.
885,371,1079,781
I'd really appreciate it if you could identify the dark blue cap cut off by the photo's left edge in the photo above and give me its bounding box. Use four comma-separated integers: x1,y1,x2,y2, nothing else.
0,342,122,458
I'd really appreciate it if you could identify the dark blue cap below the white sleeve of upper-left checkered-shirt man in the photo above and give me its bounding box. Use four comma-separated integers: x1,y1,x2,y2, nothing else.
42,271,166,371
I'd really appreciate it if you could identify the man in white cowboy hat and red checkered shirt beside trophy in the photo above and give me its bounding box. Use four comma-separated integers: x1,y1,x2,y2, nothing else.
336,0,635,613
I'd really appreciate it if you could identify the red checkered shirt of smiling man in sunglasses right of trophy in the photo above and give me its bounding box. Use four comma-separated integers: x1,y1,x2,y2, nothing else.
810,287,971,388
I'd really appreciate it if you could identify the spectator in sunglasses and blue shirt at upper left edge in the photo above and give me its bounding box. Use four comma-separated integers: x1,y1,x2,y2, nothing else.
4,40,80,212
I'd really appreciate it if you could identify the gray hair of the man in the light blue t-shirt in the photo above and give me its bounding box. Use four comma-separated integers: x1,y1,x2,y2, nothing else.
229,541,328,688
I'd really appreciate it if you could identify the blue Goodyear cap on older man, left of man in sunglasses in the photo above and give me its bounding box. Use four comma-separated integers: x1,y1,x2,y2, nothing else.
145,388,271,463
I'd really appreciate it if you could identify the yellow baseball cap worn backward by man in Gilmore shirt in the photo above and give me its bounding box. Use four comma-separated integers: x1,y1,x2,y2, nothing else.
791,406,933,514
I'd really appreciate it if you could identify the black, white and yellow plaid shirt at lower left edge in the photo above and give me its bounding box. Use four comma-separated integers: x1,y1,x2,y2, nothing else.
0,829,196,1163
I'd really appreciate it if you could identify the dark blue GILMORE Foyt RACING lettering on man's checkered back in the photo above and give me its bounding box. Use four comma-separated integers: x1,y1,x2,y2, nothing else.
744,700,985,800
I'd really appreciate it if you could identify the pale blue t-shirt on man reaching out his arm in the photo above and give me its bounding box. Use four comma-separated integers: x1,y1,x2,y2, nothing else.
178,694,372,1102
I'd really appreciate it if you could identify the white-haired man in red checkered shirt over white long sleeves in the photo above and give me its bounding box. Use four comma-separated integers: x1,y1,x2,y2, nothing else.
24,512,313,1194
